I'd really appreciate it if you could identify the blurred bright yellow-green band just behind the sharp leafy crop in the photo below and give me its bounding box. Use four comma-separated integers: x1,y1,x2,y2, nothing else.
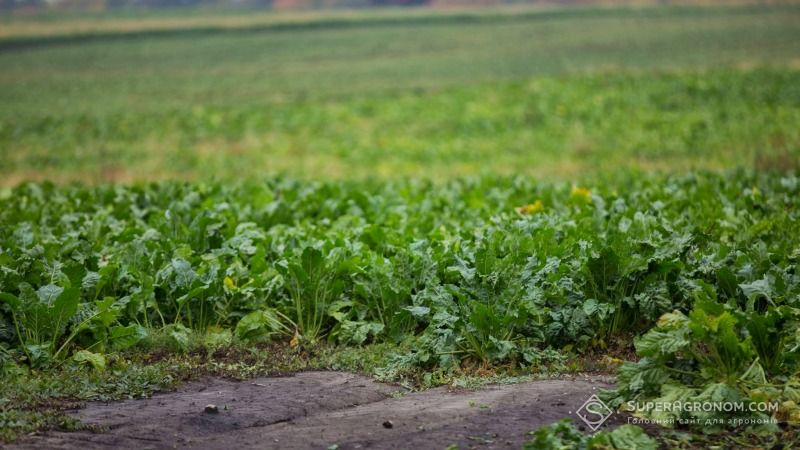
0,70,800,184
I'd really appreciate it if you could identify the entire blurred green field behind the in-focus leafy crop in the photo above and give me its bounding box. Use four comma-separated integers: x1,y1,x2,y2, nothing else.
0,6,800,185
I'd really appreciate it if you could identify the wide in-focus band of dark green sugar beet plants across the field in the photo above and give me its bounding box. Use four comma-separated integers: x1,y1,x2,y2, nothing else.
0,172,800,398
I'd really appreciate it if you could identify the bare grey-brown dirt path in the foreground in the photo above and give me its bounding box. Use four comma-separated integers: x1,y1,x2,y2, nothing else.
15,372,619,450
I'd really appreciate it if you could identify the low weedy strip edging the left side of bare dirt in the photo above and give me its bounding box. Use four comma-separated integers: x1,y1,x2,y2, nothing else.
0,333,422,442
